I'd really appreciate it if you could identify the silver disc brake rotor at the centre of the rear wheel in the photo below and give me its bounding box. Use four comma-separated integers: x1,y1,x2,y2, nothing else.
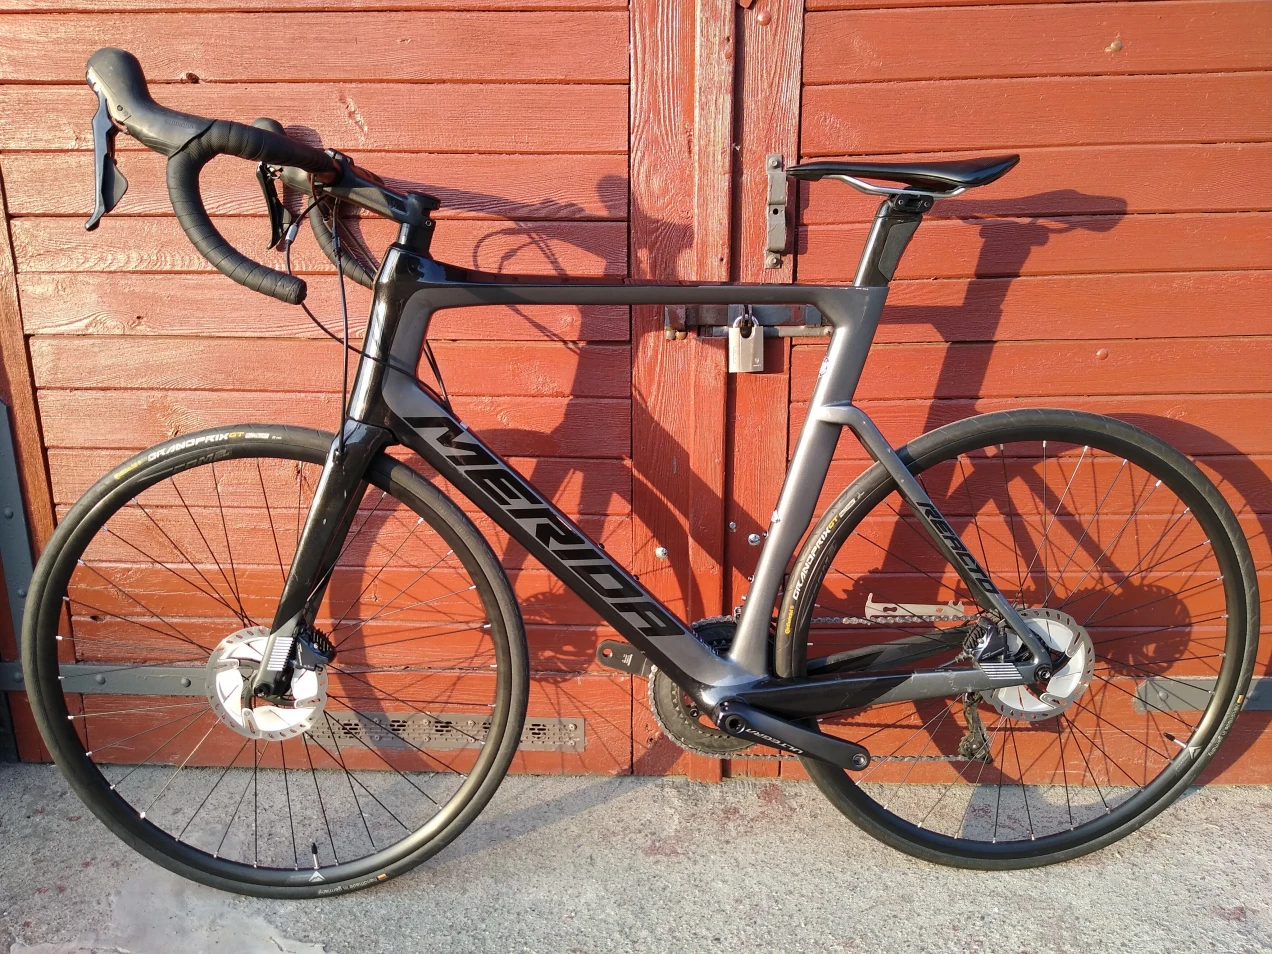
985,607,1095,722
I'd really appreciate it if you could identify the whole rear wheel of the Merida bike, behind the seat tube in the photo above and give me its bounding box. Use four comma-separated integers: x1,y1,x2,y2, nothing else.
775,408,1259,868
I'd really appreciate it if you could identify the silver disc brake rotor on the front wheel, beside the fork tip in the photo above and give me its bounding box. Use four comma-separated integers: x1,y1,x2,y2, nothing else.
206,626,327,742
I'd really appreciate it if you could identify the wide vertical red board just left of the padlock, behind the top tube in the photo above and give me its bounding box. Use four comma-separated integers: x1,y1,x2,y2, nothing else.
630,0,734,780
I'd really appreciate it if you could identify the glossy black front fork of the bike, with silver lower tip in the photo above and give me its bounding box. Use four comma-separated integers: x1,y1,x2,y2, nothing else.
247,420,393,697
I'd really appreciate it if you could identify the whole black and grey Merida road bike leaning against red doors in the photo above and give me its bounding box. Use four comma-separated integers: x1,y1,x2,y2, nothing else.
22,48,1259,897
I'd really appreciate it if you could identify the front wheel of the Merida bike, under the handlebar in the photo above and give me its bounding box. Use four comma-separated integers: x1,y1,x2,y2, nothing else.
23,425,528,897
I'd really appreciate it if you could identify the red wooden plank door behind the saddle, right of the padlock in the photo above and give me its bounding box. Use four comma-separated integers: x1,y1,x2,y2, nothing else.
790,0,1272,782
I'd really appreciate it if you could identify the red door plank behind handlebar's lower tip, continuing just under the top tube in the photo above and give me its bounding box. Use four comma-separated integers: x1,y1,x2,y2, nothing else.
18,272,630,346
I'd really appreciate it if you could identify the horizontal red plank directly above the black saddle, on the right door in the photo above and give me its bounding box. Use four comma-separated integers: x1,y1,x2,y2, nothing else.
800,73,1272,156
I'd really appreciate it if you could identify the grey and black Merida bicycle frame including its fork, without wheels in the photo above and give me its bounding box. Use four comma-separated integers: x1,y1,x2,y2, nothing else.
266,202,1051,719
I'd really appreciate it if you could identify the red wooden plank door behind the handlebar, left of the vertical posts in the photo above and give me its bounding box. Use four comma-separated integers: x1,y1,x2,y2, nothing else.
0,0,633,772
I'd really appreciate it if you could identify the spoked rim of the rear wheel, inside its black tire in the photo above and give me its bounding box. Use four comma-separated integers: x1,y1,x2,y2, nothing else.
792,429,1244,857
